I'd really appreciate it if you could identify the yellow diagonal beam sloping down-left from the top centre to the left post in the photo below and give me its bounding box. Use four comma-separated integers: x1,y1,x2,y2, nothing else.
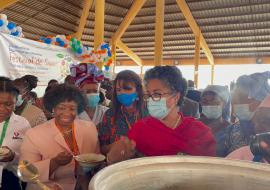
112,0,146,43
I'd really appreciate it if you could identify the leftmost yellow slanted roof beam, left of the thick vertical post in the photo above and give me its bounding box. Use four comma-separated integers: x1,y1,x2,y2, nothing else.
75,0,93,40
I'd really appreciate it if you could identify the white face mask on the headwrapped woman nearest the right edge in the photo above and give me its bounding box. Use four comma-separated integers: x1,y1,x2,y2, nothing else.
234,104,254,121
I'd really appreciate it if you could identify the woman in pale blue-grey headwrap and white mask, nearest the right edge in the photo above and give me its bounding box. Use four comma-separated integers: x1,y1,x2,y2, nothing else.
226,71,270,153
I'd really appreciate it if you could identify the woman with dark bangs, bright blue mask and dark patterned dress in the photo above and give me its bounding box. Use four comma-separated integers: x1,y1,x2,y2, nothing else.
98,70,147,154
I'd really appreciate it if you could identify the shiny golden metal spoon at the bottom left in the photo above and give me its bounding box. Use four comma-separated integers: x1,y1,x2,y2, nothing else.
17,160,51,190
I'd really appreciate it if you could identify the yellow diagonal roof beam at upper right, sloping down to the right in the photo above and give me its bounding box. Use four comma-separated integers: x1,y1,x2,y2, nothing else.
176,0,214,65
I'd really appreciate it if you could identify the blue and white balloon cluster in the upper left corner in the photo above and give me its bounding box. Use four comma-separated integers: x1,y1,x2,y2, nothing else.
0,14,23,37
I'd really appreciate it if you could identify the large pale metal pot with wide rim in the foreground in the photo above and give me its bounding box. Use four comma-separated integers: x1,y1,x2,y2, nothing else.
89,156,270,190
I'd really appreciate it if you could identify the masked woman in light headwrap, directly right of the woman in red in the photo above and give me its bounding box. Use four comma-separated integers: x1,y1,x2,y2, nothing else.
199,85,230,157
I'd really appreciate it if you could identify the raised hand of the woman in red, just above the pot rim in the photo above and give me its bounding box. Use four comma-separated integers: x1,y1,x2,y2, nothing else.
107,137,136,164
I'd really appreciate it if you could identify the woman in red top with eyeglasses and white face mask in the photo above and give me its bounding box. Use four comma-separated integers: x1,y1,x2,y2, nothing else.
108,66,216,163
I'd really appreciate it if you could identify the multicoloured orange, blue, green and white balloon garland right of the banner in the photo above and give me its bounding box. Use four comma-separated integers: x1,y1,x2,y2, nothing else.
40,35,113,71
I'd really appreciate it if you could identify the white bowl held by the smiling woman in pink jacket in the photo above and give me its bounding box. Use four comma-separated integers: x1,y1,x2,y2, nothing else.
74,153,106,167
